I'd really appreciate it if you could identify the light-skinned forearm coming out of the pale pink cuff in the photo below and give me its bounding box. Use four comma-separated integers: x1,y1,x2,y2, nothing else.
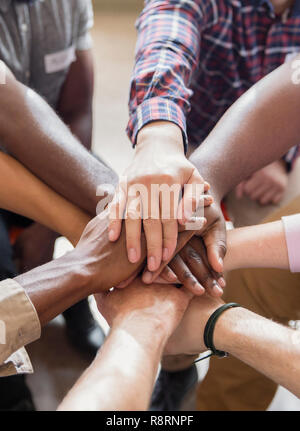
224,221,289,271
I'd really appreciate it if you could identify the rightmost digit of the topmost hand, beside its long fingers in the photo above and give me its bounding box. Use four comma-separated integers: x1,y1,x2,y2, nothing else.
178,170,207,225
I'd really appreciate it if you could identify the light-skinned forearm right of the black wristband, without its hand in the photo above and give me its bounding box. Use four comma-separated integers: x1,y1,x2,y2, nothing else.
214,308,300,397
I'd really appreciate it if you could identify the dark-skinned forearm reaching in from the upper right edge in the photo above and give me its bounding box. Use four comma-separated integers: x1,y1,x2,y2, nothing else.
191,56,300,199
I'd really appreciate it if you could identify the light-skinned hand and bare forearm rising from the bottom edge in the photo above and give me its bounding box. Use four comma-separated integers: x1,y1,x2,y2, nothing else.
59,279,192,411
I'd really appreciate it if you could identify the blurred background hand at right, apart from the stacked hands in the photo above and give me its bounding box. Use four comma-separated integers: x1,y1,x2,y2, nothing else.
236,160,288,205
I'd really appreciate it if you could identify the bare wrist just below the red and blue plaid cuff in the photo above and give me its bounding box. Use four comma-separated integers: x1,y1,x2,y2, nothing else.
136,121,184,154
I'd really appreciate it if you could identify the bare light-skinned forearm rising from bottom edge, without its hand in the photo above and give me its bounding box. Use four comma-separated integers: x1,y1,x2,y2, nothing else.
59,313,167,411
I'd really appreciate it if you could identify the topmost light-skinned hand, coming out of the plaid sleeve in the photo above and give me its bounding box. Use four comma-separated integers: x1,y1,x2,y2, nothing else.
109,122,207,272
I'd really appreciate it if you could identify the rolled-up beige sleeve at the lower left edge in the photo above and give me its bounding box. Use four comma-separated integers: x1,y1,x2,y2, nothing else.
0,279,41,376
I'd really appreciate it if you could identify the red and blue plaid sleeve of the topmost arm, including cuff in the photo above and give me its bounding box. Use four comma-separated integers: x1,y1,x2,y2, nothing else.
127,0,212,150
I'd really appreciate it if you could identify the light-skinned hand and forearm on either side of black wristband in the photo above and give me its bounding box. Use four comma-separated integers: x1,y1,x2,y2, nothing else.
167,295,300,397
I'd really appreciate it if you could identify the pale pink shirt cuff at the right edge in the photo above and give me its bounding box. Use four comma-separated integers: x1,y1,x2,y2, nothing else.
282,214,300,272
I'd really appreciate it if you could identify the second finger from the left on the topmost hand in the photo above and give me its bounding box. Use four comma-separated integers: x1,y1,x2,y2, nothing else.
125,195,142,263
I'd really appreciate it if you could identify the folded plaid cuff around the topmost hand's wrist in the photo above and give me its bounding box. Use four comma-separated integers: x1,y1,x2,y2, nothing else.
127,97,188,152
